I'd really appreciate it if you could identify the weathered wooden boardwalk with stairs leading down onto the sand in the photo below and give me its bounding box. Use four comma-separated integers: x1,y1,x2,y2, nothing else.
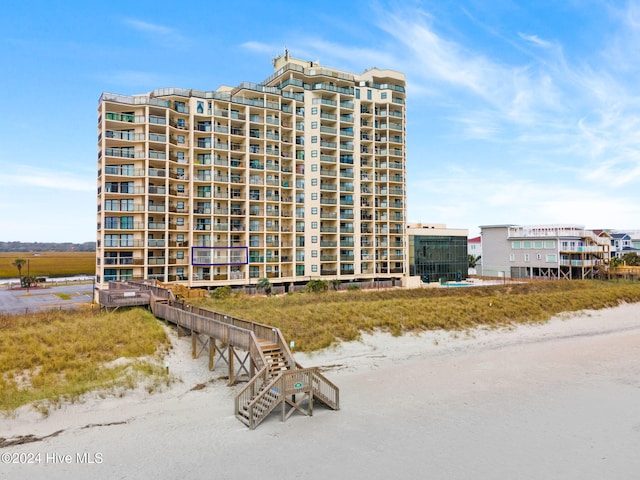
99,282,340,429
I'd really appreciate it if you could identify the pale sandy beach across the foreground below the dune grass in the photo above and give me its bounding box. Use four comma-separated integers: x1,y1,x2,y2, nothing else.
0,304,640,480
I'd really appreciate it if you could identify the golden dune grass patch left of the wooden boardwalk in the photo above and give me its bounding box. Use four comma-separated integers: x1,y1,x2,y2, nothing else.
0,309,171,413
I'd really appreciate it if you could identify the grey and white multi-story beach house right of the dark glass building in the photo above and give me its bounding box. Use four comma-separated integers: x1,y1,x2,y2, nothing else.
478,225,611,279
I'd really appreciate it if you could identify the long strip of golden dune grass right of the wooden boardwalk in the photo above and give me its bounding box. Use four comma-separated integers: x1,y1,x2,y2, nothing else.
194,280,640,351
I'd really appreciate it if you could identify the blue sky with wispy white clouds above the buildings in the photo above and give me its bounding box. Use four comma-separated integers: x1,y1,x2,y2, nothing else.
0,0,640,242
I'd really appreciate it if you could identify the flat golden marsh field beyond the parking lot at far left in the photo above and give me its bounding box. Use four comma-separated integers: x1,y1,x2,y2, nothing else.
0,252,96,278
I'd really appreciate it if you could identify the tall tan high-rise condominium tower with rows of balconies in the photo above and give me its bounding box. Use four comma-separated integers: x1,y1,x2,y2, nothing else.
96,52,406,287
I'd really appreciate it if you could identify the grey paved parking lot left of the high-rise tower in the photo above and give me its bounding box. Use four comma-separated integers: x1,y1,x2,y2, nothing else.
0,283,93,314
